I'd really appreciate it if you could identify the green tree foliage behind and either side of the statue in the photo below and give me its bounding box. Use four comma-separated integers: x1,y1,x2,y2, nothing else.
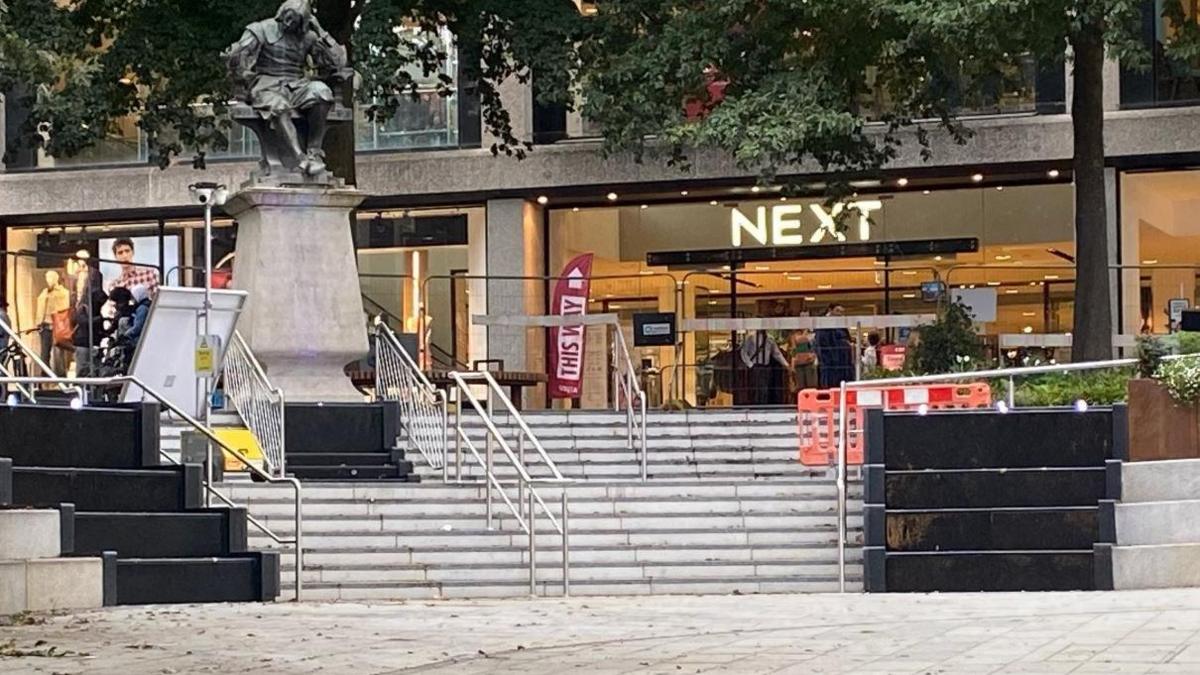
0,0,582,183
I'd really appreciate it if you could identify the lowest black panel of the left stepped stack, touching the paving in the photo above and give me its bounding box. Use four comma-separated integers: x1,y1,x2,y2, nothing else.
116,554,263,604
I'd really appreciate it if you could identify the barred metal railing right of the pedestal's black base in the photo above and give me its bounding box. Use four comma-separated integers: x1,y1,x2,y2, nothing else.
374,321,450,473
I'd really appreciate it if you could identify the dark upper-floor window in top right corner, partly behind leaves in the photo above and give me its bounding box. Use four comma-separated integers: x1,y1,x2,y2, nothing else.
1121,0,1200,108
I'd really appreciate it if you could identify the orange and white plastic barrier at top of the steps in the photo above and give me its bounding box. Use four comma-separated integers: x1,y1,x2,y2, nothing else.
797,382,991,466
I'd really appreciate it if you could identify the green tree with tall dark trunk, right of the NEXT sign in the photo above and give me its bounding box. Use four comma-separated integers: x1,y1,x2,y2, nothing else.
571,0,1200,359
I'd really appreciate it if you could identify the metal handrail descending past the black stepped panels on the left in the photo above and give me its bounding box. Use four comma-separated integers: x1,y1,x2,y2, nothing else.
0,375,304,602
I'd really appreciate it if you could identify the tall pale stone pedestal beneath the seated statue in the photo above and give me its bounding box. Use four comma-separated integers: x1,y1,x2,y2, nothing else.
226,186,368,402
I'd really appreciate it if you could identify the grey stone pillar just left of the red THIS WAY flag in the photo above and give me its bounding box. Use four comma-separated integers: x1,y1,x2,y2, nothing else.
487,194,546,410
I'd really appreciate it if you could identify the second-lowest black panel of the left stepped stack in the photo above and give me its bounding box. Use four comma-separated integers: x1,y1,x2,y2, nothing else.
76,509,230,558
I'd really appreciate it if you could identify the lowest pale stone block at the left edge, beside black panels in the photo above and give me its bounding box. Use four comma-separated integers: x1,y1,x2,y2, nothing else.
0,554,106,615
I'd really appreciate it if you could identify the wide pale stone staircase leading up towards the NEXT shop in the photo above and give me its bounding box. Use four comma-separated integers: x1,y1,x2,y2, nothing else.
228,411,862,599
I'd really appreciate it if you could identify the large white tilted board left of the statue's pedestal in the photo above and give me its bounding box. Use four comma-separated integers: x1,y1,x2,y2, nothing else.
121,286,246,417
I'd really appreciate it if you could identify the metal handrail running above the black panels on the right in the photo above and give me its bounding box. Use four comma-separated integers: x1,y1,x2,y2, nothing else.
838,354,1200,593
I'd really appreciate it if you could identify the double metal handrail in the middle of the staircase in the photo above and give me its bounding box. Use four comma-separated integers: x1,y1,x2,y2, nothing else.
450,371,572,596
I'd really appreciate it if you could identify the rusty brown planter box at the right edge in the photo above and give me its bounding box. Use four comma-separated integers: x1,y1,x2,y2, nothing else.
1129,378,1200,461
